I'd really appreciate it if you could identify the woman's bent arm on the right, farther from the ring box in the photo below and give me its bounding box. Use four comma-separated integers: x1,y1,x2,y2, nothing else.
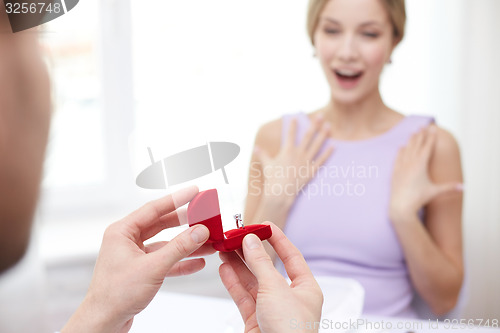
391,126,463,315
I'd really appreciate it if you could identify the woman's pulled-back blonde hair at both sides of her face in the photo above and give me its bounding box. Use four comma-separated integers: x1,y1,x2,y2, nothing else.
307,0,406,46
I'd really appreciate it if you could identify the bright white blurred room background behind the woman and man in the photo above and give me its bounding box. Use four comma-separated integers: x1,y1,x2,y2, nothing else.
1,0,500,331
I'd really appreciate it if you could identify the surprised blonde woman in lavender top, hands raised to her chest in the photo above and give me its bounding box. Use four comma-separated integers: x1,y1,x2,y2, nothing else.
245,0,463,318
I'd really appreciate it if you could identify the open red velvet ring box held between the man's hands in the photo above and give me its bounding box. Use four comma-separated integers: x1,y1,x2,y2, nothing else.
187,189,272,252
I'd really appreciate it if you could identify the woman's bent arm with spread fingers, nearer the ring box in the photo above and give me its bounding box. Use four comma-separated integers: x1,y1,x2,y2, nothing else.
244,117,333,260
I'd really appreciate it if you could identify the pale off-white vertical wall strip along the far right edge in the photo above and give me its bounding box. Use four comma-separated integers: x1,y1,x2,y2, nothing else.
457,0,500,319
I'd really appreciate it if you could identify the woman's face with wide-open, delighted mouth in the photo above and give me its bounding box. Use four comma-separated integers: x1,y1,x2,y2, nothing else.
314,0,394,104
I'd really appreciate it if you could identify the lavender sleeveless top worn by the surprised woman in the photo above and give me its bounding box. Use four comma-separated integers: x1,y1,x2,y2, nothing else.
278,113,434,318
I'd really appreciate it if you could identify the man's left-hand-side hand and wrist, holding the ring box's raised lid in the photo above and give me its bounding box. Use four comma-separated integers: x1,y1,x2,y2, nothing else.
62,187,215,333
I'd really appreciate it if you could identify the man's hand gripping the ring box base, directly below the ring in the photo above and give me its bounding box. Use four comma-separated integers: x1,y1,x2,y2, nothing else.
219,223,323,333
